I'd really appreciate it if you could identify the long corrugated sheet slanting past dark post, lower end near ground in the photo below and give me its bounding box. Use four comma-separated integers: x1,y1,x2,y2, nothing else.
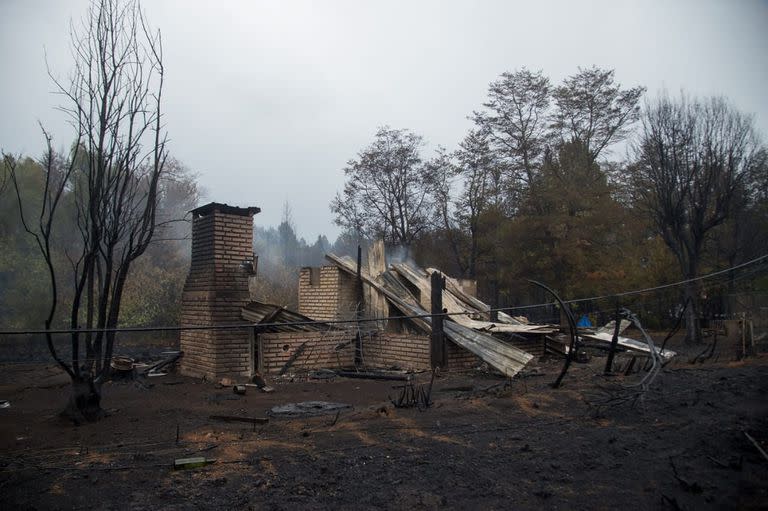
326,254,533,378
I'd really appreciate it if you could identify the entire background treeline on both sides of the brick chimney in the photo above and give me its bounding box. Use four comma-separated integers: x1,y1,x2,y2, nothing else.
0,67,768,329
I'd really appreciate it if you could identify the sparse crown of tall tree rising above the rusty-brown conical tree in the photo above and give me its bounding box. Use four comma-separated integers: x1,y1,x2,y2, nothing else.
552,66,645,161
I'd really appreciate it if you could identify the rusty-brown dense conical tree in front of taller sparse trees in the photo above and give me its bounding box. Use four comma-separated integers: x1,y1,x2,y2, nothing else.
506,140,626,297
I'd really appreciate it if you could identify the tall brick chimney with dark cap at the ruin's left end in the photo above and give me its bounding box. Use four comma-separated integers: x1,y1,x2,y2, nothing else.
180,202,261,379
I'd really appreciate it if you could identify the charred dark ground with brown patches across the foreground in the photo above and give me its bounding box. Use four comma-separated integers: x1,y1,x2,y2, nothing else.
0,340,768,510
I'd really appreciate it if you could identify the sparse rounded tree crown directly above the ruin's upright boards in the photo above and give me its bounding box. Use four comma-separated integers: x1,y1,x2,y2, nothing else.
331,127,430,247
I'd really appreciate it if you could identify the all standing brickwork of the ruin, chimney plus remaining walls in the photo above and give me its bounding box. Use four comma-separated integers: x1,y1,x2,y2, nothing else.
180,214,479,379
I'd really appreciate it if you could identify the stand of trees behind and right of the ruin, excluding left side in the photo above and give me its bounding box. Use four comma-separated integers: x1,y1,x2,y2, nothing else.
331,67,768,337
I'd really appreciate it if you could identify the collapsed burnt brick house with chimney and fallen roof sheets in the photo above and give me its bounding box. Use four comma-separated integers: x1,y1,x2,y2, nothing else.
180,203,680,379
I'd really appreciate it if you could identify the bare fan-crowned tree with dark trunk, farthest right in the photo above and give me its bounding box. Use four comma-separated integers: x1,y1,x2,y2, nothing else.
630,95,764,342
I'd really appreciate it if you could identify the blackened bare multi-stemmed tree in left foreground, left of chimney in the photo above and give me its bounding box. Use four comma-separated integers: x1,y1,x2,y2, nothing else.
11,0,167,421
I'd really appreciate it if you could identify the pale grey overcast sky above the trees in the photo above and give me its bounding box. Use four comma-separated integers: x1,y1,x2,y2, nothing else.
0,0,768,242
